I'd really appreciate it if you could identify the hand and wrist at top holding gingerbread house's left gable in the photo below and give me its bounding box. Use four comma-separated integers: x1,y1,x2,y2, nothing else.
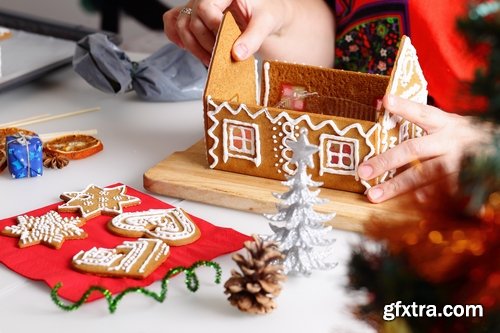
163,0,335,67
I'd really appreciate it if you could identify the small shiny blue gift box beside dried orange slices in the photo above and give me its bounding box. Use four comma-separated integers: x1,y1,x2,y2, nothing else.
5,134,43,178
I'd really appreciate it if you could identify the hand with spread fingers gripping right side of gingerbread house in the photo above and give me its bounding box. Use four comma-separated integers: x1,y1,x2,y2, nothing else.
358,95,487,203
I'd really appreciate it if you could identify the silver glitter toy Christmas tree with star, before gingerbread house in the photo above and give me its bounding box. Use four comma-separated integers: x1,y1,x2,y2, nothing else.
265,128,336,275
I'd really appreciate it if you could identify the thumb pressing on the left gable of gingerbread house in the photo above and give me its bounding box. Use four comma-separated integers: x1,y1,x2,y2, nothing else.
232,13,275,61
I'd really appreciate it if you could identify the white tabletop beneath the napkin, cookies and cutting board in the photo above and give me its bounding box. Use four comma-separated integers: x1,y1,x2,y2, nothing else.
0,68,372,333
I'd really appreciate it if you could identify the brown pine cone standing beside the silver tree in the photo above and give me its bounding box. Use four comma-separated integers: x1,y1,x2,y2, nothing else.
224,235,286,314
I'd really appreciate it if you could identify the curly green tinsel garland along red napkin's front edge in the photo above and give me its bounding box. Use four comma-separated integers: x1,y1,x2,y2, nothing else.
50,261,222,313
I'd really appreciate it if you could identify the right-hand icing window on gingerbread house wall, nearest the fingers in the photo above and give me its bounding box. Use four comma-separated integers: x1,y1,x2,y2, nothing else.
320,134,359,178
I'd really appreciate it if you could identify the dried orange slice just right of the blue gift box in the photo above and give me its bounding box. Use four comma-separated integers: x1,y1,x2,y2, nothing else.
43,134,104,160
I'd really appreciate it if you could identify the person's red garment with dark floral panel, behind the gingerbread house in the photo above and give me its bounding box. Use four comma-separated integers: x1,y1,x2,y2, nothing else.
327,0,482,112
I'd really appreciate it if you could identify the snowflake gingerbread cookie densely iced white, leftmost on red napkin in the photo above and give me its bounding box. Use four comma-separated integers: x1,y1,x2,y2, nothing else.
1,210,87,249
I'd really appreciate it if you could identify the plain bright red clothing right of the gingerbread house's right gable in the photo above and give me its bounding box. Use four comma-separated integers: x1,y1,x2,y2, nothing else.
409,0,485,113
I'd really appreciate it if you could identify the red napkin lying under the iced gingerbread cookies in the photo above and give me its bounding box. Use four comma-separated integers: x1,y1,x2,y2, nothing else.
0,184,251,302
